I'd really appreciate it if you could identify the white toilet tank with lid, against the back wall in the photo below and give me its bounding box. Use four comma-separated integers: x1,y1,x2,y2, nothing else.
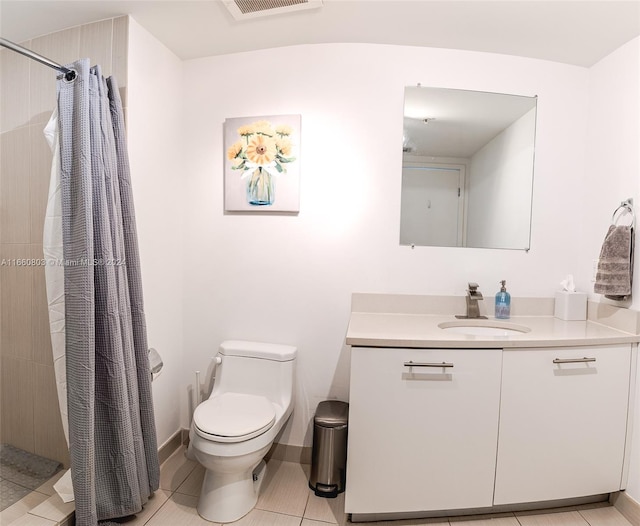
211,340,297,411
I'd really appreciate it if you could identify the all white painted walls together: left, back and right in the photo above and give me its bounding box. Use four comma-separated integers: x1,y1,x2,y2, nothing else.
121,20,640,500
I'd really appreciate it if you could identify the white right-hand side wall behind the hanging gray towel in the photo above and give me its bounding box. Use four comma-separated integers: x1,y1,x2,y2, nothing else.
577,38,640,502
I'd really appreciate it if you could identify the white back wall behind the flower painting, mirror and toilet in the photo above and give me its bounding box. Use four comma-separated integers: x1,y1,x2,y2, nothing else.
181,44,592,452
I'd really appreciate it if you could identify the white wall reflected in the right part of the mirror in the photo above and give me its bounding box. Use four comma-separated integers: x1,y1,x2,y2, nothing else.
467,109,536,248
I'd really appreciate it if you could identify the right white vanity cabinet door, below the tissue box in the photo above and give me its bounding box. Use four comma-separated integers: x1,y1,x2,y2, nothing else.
494,344,631,505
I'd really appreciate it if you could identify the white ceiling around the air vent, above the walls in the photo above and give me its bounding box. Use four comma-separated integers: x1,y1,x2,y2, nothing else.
0,0,640,67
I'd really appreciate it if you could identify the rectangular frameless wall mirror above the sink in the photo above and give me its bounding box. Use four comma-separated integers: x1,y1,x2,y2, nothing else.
400,86,537,250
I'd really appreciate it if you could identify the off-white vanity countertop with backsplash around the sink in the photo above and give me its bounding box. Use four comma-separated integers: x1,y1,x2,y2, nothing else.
346,295,640,348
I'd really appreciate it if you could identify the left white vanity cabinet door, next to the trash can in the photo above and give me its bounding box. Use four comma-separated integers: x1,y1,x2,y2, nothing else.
345,347,502,514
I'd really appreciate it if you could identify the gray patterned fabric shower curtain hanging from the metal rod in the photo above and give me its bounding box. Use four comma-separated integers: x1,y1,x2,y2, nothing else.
58,59,159,526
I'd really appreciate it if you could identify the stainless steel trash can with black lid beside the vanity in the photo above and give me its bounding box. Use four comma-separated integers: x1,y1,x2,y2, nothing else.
309,400,349,498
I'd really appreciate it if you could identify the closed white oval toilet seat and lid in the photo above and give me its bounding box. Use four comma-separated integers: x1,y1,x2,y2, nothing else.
193,393,276,442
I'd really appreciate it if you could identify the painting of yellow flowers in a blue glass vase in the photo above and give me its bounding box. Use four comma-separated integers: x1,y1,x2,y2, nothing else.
224,115,301,212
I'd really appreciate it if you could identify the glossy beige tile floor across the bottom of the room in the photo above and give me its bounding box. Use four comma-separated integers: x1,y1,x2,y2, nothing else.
0,448,640,526
